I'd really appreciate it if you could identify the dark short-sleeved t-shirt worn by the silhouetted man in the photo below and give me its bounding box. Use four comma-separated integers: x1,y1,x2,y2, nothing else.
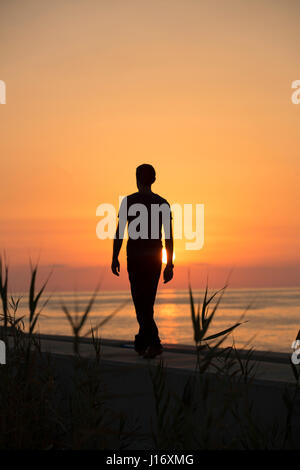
118,192,172,256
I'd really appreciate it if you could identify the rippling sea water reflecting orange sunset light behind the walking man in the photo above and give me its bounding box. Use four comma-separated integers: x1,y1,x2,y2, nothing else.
14,288,300,352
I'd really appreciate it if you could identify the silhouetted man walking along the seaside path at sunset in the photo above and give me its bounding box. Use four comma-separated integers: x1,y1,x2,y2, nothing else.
111,164,173,358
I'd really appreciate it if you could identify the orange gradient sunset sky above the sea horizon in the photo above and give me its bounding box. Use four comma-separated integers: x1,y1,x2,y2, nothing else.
0,0,300,288
